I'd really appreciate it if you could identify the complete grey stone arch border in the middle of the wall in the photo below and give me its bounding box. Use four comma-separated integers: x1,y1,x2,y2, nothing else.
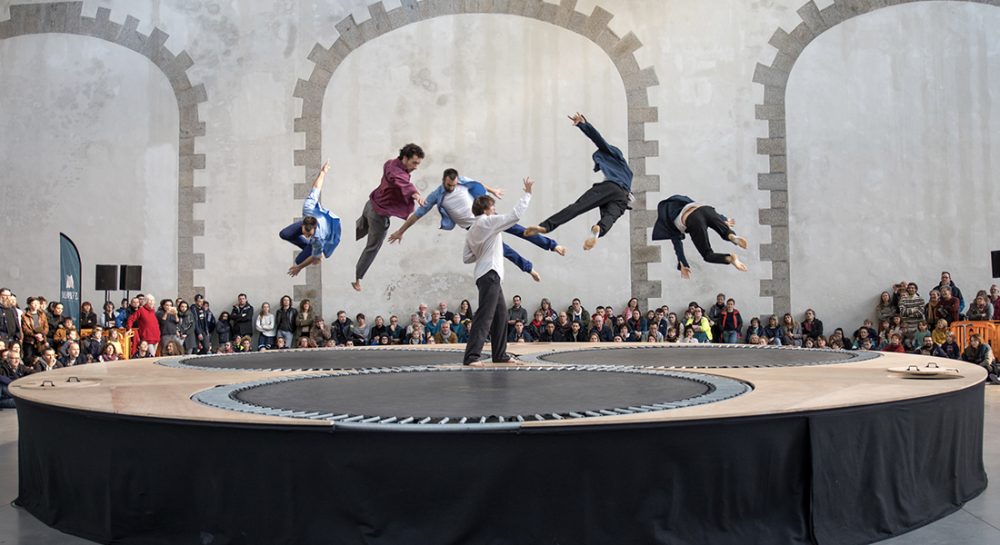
293,0,662,306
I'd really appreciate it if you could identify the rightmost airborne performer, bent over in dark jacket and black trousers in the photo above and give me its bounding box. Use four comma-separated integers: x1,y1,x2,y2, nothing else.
653,195,747,278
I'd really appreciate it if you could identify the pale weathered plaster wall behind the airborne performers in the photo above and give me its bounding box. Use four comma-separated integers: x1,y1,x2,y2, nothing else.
0,0,1000,330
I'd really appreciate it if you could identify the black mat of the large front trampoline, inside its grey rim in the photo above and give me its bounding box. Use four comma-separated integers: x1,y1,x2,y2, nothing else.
234,368,714,419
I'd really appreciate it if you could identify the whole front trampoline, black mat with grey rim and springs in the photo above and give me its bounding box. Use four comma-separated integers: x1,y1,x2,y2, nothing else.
195,366,751,431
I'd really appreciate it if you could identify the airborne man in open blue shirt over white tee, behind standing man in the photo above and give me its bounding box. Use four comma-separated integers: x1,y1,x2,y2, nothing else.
389,168,566,282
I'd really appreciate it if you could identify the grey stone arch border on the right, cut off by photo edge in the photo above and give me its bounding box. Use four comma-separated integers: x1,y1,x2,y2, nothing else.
753,0,1000,315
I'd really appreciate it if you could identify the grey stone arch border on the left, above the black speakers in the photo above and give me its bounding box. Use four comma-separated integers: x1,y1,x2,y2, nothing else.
0,2,208,295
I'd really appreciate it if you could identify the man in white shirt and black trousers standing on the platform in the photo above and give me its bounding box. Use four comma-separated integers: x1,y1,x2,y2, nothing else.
462,178,535,365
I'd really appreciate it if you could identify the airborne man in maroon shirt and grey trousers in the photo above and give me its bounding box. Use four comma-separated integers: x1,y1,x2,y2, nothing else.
351,144,424,291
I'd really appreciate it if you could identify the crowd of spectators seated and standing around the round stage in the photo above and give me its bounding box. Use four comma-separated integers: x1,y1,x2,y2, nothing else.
0,272,1000,407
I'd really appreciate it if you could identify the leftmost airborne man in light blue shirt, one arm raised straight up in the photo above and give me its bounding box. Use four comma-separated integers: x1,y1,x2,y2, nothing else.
278,157,340,276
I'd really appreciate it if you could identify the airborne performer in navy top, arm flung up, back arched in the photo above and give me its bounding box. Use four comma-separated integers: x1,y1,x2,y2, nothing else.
524,112,632,250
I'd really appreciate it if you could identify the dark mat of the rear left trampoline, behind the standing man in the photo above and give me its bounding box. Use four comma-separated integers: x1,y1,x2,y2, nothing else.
179,348,489,371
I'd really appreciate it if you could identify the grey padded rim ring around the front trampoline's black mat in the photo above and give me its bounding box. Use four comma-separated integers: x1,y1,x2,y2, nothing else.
192,365,752,432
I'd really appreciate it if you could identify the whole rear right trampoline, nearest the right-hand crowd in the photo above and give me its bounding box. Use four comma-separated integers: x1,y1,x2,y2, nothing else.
529,344,879,369
